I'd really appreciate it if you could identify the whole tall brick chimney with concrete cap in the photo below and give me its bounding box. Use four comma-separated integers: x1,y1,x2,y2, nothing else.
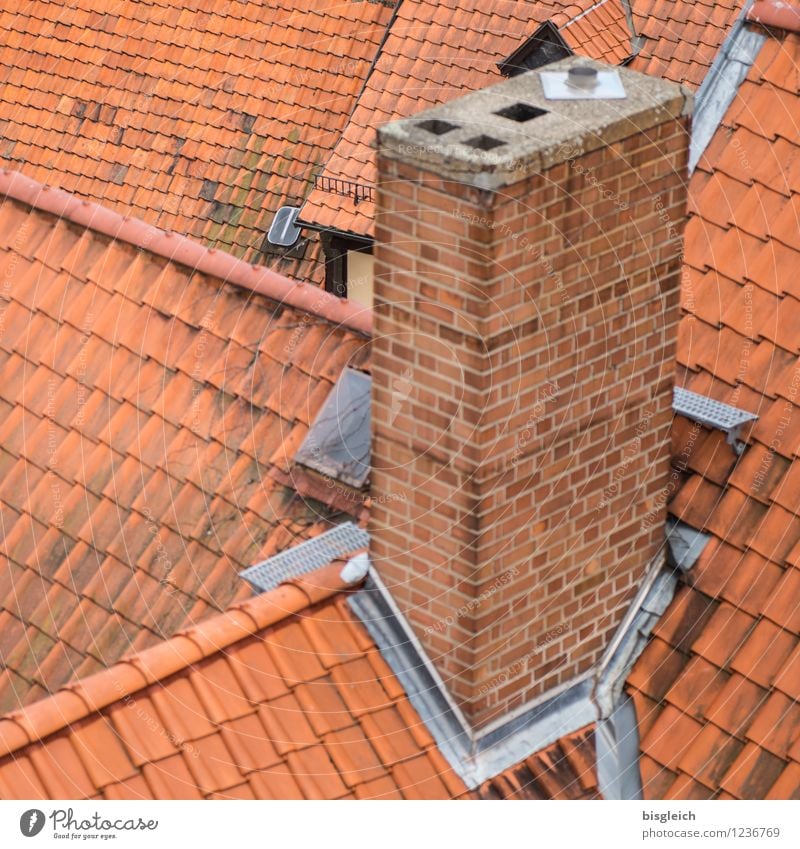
371,57,690,729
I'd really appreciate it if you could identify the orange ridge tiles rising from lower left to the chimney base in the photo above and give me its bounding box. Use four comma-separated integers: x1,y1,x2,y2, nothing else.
0,555,364,758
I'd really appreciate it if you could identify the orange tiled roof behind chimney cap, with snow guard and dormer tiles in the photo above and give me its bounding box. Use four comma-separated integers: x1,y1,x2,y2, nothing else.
300,0,630,236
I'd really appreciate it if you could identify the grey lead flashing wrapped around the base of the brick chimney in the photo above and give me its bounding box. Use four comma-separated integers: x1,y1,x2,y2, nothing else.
347,522,708,799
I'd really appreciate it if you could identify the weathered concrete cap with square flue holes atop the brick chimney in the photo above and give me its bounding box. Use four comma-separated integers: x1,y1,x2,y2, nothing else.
378,56,692,189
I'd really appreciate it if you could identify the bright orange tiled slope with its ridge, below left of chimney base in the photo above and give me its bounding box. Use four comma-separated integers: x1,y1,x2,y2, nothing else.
0,562,596,799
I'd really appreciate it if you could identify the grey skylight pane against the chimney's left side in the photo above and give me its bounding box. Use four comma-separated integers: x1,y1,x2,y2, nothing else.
294,368,372,489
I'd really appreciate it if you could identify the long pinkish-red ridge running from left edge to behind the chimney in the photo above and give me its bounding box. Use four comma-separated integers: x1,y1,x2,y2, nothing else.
0,169,372,335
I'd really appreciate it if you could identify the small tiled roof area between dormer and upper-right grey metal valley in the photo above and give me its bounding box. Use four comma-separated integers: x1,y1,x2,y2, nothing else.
630,0,745,88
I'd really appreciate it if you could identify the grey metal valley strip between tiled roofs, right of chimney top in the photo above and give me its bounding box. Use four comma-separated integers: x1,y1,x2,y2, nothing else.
689,0,766,174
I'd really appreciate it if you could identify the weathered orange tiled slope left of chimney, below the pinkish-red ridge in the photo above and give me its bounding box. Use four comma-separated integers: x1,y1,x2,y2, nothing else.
0,175,366,711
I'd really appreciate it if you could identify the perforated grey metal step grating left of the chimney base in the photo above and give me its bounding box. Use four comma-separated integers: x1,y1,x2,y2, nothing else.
241,522,369,592
